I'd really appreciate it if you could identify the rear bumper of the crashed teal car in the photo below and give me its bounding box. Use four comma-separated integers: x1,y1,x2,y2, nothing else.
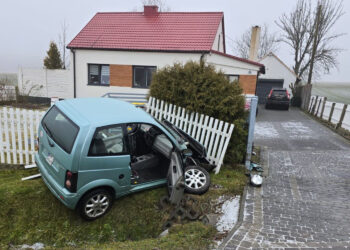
35,154,79,209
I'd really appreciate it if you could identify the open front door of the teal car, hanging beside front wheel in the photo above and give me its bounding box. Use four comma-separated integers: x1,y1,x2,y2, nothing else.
167,151,185,205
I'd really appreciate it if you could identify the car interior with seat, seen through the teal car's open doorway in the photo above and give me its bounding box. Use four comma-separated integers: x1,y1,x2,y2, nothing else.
127,123,173,184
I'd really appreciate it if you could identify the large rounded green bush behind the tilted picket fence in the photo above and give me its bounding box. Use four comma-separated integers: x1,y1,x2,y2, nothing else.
150,61,247,163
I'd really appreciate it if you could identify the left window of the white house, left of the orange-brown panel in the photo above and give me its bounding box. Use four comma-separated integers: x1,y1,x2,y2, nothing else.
88,64,109,86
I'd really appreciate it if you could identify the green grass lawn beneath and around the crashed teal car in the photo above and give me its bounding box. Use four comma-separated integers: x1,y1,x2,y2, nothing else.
0,166,246,249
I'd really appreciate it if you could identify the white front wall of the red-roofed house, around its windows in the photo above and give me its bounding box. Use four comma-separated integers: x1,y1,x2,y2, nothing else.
71,50,259,97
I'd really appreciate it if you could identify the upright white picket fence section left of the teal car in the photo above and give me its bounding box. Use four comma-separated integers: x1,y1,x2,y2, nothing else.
0,107,45,164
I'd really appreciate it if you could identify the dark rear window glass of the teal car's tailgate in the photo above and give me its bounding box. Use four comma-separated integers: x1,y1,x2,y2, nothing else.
42,106,79,154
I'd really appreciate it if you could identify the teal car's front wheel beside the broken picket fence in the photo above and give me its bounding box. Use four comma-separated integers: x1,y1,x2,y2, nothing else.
184,166,210,194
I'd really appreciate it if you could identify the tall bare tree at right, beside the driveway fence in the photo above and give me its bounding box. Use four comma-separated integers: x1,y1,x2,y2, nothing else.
276,0,344,83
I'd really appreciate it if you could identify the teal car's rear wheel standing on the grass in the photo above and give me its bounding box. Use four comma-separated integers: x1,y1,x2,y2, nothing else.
78,188,113,221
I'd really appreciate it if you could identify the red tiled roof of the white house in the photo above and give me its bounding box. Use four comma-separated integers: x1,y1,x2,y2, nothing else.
67,12,223,51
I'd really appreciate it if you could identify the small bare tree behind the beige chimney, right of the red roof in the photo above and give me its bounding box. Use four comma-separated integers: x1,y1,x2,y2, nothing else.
233,24,280,58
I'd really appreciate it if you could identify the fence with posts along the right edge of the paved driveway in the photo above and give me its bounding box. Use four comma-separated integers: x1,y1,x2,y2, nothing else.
308,96,350,131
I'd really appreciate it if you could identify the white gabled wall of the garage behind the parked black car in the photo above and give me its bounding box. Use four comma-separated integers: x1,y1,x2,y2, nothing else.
259,55,296,93
